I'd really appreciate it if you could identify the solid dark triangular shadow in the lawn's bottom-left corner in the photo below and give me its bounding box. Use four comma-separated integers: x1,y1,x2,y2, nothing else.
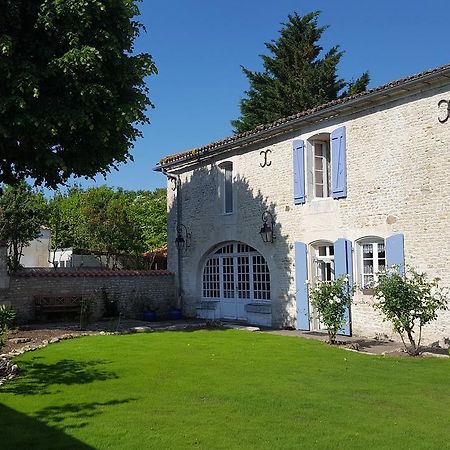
0,404,93,450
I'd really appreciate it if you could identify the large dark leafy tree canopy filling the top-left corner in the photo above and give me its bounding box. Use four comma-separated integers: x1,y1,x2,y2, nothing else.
0,0,156,187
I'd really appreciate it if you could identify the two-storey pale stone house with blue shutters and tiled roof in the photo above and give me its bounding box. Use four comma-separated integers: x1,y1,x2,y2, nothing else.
155,65,450,342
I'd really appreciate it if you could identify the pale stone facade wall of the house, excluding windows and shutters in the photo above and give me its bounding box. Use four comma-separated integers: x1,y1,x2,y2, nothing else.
160,67,450,342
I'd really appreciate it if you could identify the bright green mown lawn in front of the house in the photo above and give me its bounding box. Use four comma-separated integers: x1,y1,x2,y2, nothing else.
0,330,450,450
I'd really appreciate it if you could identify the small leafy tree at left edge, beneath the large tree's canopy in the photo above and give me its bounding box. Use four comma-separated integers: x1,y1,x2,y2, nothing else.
0,182,47,271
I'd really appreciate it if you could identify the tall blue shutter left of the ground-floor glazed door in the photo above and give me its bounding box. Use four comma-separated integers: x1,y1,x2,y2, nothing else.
295,242,309,330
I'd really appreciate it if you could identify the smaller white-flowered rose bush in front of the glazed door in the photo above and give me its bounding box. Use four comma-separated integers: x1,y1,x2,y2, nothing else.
309,276,355,344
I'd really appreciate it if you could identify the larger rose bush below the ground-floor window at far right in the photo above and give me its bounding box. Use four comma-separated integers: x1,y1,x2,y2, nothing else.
373,266,448,356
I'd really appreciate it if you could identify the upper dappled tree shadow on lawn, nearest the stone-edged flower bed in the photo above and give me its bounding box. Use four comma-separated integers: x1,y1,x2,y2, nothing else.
0,357,118,395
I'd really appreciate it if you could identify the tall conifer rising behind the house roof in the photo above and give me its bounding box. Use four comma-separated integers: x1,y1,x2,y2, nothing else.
231,11,369,133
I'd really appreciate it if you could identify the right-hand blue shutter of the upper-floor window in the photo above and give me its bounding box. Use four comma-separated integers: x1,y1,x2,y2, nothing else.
331,127,347,198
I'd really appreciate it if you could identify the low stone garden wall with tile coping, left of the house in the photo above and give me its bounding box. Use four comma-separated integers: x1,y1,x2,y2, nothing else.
0,268,176,323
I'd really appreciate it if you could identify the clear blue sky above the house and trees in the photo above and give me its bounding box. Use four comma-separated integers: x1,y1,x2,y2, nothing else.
83,0,450,189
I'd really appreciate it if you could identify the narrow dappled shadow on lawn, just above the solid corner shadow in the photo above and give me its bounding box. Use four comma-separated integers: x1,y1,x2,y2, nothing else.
34,398,137,430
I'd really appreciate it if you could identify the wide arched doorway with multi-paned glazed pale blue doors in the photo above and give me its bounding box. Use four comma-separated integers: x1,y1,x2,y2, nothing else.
202,242,270,320
